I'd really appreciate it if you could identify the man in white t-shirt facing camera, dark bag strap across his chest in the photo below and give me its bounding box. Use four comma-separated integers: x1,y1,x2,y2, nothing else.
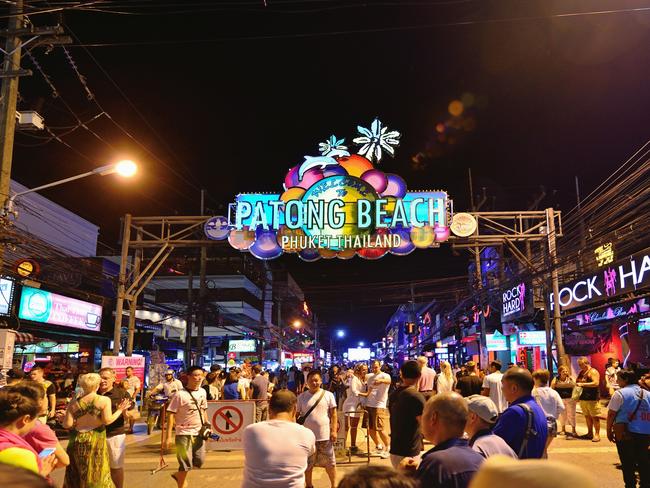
298,370,338,488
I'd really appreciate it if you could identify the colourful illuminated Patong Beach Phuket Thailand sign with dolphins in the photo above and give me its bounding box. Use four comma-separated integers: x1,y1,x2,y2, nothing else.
206,119,453,261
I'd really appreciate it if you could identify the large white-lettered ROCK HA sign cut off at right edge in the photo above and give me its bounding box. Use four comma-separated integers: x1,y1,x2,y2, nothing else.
549,252,650,310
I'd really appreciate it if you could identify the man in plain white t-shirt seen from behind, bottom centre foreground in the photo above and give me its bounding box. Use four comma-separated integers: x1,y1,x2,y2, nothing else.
242,390,316,488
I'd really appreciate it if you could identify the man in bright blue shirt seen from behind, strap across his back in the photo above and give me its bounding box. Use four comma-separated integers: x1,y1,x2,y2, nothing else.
493,368,548,459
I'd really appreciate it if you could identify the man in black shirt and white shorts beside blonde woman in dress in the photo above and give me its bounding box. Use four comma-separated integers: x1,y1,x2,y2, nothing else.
98,368,131,488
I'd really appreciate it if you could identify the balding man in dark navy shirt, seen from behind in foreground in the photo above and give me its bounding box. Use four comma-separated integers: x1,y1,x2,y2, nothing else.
400,392,485,488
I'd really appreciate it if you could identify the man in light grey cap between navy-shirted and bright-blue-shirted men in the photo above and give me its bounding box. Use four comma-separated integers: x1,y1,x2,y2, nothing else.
465,395,517,459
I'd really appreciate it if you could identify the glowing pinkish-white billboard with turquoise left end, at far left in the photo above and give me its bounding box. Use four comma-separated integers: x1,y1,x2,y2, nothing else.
18,286,102,332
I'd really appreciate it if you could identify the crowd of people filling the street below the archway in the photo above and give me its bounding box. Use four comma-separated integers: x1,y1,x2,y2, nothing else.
0,357,650,488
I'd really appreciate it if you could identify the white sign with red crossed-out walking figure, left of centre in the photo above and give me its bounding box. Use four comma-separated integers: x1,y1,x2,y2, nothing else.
208,400,255,451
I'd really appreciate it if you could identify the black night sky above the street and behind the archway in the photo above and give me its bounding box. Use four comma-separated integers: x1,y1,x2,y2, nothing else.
7,0,650,341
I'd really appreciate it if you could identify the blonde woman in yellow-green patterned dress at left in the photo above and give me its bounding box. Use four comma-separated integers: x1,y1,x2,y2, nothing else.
63,373,131,488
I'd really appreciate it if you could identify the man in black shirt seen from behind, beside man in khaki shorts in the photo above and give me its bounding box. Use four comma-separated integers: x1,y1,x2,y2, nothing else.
388,361,426,468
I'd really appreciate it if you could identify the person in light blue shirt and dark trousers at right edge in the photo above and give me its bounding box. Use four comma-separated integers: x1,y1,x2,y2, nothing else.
607,369,650,488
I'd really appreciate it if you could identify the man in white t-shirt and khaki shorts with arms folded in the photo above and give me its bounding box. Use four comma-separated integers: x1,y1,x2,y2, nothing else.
366,361,391,459
